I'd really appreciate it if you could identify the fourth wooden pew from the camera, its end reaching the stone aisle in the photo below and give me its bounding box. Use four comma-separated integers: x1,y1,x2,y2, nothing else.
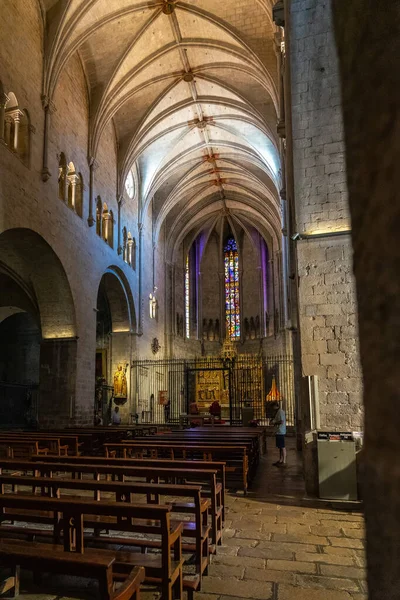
0,457,223,545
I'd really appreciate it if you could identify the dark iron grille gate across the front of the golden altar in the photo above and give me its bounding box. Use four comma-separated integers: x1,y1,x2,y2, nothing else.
132,354,295,426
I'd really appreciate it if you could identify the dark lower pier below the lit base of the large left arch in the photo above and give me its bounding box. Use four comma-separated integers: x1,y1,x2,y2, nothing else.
39,338,78,428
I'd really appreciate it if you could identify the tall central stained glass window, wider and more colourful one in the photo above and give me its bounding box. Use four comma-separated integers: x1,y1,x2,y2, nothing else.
224,237,240,340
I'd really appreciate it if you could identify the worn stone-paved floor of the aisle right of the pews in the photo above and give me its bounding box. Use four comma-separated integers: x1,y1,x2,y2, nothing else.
3,439,367,600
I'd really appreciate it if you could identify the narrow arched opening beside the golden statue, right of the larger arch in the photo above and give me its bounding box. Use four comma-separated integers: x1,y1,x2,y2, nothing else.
94,267,136,424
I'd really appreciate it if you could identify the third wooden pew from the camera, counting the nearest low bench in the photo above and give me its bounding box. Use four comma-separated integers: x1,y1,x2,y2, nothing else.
0,475,210,580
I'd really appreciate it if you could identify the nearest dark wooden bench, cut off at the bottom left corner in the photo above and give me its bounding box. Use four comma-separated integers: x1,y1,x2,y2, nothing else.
0,540,144,600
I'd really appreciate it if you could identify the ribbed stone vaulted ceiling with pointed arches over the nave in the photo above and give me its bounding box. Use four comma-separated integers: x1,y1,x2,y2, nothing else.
42,0,280,255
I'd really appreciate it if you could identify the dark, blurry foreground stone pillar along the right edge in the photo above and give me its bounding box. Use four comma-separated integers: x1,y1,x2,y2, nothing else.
332,0,400,600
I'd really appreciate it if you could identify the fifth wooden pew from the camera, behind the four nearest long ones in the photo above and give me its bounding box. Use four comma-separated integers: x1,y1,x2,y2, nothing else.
104,440,249,494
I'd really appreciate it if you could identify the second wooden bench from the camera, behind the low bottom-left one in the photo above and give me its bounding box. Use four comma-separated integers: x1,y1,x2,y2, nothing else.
0,494,183,600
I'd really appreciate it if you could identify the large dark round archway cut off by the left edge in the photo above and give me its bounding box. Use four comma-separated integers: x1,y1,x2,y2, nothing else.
0,229,77,427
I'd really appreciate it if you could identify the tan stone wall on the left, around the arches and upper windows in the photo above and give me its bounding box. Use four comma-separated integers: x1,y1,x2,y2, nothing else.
0,0,165,426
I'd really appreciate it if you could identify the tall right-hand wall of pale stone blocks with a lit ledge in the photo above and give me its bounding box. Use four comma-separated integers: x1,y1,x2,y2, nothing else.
290,0,363,430
